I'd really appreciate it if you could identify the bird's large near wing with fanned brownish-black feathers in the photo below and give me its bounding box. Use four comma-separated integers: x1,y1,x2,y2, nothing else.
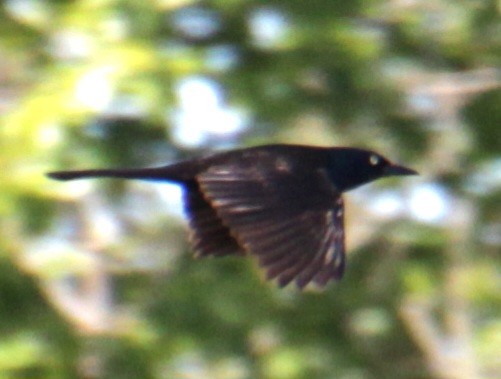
196,165,345,288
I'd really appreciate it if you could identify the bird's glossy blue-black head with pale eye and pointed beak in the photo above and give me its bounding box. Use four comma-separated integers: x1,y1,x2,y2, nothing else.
329,148,418,192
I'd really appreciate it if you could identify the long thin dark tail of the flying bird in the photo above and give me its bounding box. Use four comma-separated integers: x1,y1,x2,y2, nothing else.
47,164,190,182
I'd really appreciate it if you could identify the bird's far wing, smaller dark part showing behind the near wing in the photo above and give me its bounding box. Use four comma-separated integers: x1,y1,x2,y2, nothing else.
183,184,242,257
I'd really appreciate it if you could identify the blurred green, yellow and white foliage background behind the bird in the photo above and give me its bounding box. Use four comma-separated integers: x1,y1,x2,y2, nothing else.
0,0,501,379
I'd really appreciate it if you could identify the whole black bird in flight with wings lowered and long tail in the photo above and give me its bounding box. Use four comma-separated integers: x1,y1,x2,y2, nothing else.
48,145,417,288
